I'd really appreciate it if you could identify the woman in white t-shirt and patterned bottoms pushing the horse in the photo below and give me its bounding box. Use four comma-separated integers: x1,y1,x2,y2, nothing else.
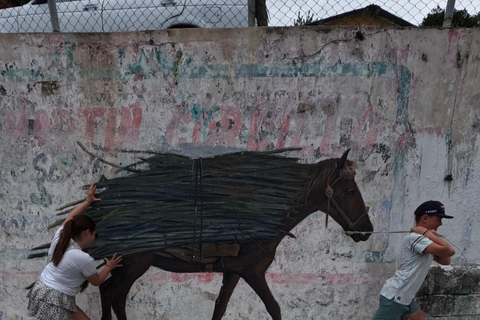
27,184,122,320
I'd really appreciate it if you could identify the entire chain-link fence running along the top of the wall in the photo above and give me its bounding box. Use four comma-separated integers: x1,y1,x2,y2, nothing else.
0,0,480,33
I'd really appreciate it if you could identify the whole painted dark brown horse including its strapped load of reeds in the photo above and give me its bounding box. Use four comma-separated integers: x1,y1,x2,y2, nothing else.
30,149,373,320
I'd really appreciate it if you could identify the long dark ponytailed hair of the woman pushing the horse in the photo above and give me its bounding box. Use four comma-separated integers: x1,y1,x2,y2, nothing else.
52,215,96,267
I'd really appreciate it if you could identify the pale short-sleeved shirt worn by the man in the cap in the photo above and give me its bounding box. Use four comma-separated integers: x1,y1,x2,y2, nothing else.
380,232,433,305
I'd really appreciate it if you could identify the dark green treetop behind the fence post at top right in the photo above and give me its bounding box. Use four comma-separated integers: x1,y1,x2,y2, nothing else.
420,6,480,28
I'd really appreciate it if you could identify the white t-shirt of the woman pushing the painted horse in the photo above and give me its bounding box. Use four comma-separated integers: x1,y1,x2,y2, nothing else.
40,226,97,296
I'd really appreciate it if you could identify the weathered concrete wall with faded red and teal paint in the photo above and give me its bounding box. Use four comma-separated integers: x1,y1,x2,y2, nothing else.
0,27,480,319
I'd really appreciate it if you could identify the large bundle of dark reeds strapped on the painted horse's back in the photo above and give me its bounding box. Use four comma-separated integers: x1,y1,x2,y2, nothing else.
32,149,313,259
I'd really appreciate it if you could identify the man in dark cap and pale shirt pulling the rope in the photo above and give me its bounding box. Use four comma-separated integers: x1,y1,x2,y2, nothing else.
373,200,455,320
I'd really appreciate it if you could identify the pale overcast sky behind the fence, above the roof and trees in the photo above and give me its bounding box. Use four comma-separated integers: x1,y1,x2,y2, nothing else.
267,0,480,26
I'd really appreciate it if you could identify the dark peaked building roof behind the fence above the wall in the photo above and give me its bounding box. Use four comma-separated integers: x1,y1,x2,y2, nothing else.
307,4,416,27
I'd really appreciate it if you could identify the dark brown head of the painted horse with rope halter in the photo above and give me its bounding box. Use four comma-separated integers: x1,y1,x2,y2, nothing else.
307,149,373,242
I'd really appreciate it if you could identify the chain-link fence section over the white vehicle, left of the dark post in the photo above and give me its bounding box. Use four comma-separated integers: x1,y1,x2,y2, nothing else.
0,0,249,33
